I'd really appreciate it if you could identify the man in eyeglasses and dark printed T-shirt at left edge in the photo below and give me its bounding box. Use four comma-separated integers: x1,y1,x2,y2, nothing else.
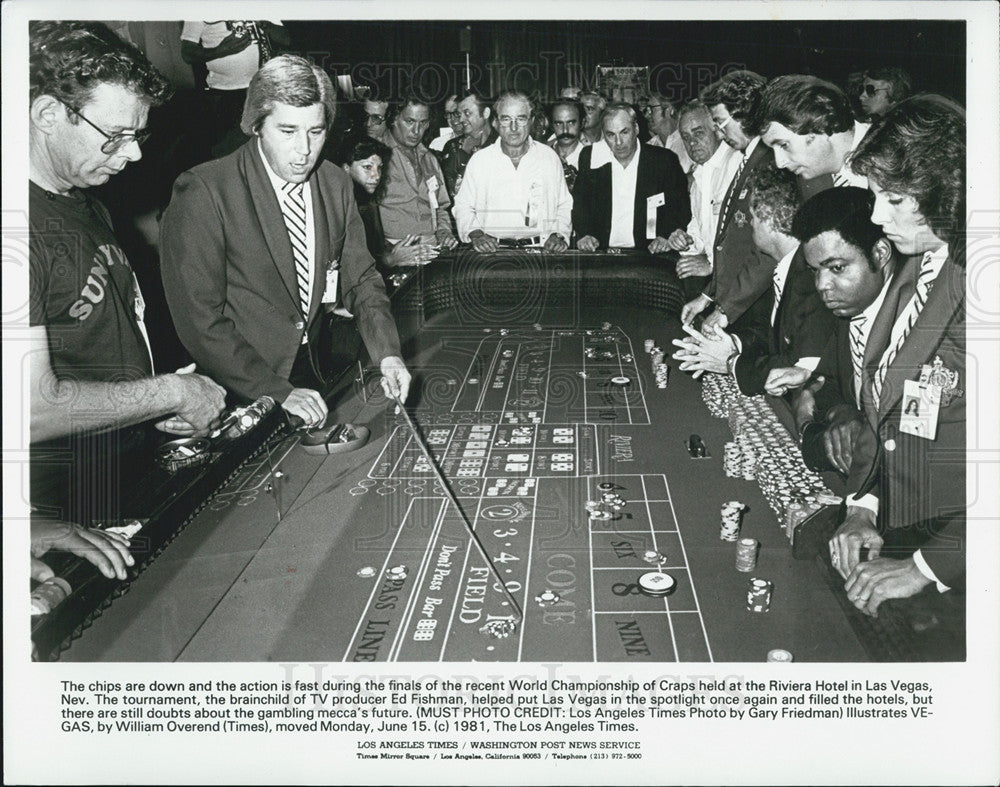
24,22,225,580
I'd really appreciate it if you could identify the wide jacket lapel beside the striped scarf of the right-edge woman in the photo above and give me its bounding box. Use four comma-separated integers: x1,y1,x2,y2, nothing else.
879,255,965,417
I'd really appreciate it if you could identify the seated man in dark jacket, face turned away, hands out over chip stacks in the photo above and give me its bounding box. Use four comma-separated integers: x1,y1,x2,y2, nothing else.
674,165,834,396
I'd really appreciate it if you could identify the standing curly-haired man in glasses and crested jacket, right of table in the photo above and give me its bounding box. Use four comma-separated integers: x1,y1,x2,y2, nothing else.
681,71,777,336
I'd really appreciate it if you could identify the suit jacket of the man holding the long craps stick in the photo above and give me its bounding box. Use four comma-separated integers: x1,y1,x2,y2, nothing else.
160,138,400,402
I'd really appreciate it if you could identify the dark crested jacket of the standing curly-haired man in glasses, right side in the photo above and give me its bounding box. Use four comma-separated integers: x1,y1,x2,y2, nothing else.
704,142,778,326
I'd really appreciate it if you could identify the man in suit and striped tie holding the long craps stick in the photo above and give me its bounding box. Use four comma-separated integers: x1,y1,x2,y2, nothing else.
160,55,410,426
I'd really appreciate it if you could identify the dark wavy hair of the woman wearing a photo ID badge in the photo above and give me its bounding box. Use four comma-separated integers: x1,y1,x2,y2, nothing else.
851,94,965,244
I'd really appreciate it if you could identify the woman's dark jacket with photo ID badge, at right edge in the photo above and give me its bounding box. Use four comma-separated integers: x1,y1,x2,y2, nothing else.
848,252,968,586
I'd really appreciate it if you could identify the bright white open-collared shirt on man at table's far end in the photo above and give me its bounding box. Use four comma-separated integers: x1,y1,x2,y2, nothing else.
454,138,573,243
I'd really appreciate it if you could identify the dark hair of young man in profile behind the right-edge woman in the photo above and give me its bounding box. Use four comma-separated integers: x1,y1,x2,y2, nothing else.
757,74,854,136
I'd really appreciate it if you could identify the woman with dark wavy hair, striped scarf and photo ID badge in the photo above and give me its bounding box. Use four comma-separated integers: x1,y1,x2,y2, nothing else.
768,96,967,615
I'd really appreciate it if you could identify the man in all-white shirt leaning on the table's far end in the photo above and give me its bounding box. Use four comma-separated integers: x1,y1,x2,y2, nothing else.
455,91,573,253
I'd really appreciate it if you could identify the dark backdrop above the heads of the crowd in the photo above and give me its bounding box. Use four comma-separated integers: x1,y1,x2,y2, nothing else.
284,19,966,104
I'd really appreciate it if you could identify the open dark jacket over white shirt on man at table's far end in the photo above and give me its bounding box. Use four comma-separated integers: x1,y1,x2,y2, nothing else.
573,143,691,249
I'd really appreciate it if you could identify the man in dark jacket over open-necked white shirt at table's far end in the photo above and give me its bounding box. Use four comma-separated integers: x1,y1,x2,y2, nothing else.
573,104,691,254
